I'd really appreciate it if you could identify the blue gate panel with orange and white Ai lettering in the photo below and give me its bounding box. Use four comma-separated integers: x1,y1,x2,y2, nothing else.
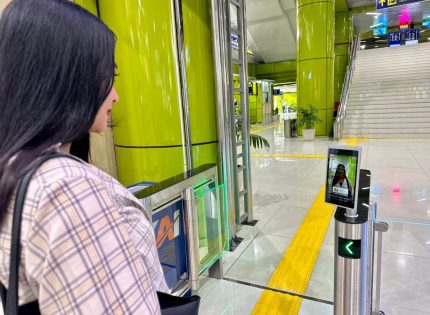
152,200,188,289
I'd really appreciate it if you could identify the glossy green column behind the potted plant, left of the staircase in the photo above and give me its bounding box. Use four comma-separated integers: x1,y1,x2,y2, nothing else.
297,0,335,136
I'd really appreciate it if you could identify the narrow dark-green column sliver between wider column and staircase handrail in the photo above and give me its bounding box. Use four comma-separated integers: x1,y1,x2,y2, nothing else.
334,11,352,102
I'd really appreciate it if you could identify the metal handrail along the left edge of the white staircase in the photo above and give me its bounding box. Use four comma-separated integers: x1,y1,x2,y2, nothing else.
334,35,360,139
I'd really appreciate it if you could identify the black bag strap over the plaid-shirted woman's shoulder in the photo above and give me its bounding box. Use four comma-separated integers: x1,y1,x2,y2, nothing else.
5,152,82,315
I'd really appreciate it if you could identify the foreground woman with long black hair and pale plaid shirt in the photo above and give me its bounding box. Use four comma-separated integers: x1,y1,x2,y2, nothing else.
0,0,167,314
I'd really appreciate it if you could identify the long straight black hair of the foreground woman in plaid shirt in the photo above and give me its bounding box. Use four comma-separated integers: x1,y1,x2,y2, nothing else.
0,0,115,220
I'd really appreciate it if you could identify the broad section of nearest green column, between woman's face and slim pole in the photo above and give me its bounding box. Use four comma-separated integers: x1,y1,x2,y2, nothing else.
99,0,184,185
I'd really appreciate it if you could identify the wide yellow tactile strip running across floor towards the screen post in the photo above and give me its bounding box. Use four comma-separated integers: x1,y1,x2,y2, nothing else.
252,187,334,315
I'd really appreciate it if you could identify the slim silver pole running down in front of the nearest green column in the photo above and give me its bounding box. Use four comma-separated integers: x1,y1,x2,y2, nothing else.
172,0,193,170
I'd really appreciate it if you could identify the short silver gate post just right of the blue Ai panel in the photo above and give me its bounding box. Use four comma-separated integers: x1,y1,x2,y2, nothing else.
183,187,200,290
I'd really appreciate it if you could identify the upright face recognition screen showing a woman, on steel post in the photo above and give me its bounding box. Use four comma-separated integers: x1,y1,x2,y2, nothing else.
325,146,361,209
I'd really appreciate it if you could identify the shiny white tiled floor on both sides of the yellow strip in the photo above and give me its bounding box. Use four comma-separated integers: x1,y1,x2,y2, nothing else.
200,123,430,315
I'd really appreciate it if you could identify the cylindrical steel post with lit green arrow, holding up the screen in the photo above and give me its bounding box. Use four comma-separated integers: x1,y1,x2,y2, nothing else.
334,170,376,315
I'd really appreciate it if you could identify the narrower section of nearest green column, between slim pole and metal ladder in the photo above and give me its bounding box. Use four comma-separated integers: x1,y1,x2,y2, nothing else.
182,0,218,167
